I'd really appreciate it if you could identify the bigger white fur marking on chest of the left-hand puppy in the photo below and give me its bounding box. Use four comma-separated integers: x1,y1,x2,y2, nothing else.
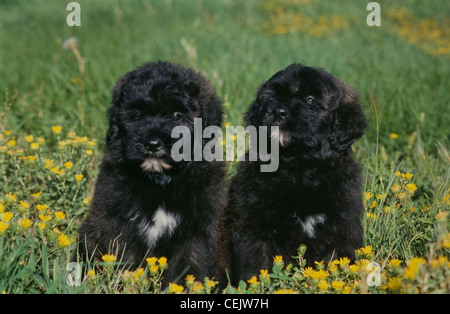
130,204,181,250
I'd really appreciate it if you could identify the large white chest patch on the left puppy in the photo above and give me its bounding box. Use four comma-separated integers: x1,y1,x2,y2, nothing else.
139,206,180,249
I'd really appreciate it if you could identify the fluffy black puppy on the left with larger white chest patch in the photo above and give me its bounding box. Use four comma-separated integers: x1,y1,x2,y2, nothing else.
79,62,226,284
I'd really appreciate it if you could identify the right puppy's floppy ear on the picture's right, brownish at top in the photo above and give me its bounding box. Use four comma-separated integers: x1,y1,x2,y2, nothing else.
329,82,367,152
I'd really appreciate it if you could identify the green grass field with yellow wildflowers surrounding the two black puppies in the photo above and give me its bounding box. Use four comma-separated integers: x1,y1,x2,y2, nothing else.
0,0,450,293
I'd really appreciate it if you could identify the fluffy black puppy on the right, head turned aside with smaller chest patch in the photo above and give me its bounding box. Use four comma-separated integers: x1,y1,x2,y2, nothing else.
219,64,366,284
